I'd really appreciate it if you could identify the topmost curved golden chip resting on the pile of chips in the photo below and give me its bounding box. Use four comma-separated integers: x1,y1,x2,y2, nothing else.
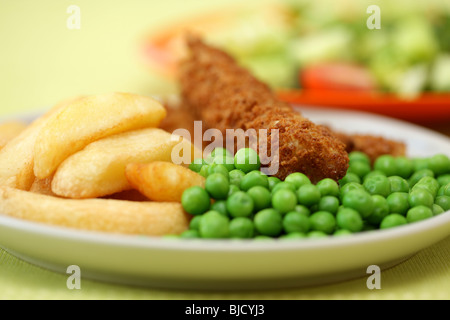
34,93,166,179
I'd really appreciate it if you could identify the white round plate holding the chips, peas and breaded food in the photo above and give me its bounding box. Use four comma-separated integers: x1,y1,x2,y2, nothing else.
0,108,450,290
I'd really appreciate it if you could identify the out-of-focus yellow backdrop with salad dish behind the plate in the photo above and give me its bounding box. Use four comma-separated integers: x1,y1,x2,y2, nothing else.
0,0,450,135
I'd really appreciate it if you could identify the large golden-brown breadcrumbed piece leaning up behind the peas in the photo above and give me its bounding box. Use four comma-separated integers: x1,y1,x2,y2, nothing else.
179,36,349,182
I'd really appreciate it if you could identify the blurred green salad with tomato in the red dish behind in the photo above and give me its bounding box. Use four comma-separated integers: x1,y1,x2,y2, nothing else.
207,0,450,98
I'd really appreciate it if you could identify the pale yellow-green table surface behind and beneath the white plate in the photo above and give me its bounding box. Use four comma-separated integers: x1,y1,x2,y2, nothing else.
0,0,450,300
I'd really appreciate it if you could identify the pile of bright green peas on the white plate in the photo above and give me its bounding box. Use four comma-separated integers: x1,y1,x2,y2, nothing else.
180,148,450,239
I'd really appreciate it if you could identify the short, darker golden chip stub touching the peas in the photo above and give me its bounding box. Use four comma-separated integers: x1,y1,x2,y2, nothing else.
125,161,205,202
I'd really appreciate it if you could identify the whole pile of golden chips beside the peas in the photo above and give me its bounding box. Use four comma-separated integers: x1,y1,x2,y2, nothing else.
0,93,199,236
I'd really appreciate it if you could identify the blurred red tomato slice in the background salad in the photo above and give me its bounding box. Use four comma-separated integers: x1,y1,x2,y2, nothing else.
299,63,377,91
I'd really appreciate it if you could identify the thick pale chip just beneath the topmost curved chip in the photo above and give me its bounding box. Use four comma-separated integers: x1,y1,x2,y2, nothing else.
52,128,190,199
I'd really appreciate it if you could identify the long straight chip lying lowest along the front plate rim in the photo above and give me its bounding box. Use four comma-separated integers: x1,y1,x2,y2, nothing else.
0,187,190,236
